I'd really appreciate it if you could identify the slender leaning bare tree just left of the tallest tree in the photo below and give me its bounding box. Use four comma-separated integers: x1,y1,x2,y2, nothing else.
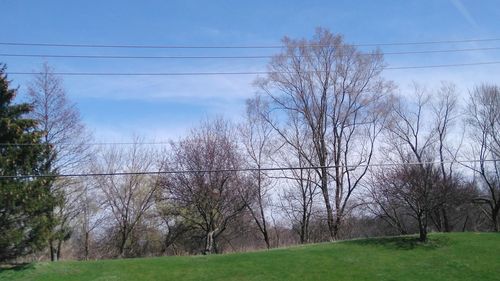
239,96,275,249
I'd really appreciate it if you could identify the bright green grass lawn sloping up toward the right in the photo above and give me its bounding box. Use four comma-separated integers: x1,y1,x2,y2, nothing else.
0,233,500,281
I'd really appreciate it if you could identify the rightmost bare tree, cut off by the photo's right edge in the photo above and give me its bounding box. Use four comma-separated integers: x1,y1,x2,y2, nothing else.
467,84,500,232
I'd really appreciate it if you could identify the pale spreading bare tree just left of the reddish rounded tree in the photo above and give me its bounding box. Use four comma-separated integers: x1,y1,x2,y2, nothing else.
93,139,161,257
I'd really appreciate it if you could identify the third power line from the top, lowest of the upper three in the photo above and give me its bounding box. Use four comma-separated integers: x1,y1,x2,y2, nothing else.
7,61,500,76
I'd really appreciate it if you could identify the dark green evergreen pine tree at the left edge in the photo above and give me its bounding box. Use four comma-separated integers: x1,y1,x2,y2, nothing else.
0,65,55,262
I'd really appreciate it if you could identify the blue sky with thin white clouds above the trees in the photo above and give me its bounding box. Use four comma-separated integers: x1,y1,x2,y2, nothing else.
0,0,500,142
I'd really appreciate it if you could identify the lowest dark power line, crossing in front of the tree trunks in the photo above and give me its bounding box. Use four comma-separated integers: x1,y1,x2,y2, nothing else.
0,159,494,179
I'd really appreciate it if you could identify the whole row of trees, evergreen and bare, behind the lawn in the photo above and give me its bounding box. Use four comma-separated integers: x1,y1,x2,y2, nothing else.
0,29,500,262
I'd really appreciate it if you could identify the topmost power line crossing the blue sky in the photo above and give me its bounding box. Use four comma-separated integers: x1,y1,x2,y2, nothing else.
0,38,500,49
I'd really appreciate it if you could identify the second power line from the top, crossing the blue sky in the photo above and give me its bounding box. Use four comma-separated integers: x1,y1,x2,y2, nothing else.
0,47,500,59
